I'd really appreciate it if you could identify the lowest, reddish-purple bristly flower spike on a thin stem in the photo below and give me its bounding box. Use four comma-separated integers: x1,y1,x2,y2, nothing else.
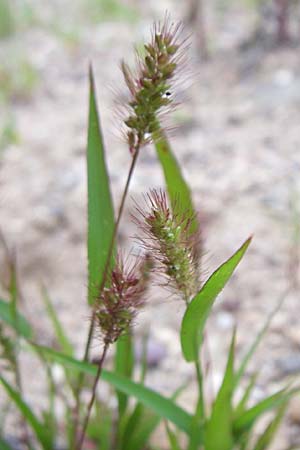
95,255,151,345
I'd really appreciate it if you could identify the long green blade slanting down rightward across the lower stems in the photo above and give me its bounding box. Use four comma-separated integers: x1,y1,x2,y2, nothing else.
37,346,196,433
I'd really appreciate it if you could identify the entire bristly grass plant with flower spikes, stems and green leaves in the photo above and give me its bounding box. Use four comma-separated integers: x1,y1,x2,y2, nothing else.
0,17,299,450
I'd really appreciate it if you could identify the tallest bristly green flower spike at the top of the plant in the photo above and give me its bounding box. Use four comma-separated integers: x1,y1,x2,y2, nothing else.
121,17,185,154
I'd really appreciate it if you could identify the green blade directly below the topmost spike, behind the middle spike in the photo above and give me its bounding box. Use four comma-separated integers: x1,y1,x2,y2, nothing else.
154,125,199,233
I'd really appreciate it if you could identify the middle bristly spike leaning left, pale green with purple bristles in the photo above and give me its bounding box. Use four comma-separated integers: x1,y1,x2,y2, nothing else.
135,190,199,302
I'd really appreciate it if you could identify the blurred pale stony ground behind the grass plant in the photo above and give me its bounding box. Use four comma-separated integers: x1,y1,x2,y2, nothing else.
0,0,300,450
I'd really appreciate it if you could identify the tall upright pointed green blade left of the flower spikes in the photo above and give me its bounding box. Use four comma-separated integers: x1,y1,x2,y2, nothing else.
87,67,114,304
